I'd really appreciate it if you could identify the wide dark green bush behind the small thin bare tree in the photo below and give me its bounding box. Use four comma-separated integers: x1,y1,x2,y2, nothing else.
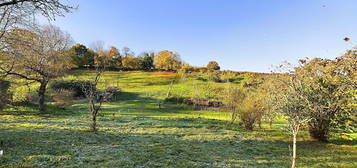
50,80,96,97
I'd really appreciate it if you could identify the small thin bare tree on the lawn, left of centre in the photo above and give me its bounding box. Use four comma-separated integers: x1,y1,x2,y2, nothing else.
82,66,113,131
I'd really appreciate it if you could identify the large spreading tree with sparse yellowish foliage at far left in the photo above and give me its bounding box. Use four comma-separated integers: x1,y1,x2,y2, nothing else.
0,25,72,112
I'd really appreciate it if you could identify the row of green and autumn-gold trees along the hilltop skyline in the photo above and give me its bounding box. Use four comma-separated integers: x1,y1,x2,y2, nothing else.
69,44,220,72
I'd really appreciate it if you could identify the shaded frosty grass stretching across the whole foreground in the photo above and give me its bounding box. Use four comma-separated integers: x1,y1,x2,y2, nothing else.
0,117,356,167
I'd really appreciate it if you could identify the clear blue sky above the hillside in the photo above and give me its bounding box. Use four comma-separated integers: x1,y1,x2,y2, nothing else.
41,0,357,72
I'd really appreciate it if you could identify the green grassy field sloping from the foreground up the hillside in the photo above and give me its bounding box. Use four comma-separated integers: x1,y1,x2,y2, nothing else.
0,71,357,168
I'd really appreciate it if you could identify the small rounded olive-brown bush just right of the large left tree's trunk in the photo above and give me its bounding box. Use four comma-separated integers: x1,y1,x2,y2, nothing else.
53,90,75,109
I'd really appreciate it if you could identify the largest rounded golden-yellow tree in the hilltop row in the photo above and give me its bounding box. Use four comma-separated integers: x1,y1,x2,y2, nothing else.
154,50,181,71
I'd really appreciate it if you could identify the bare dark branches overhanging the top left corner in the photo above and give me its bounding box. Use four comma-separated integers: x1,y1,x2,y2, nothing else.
0,0,76,40
